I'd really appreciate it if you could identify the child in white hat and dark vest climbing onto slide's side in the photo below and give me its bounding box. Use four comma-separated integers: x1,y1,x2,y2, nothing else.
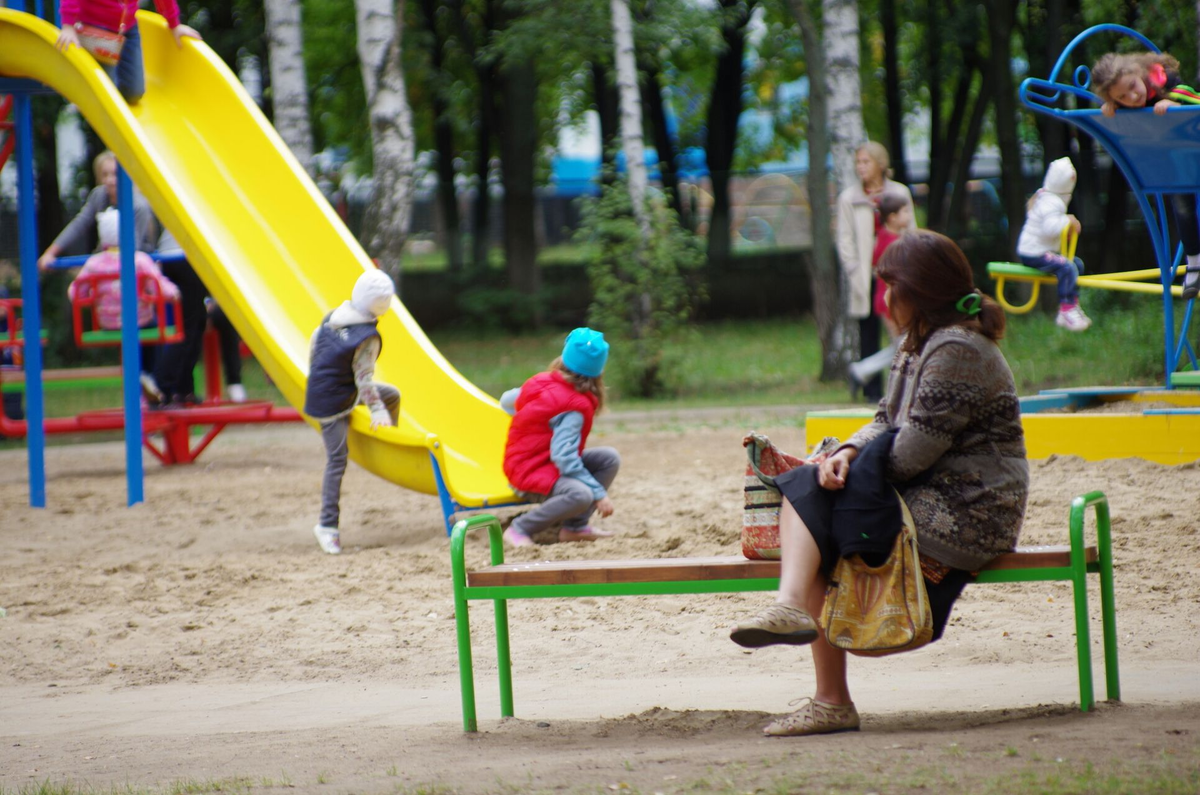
304,270,400,555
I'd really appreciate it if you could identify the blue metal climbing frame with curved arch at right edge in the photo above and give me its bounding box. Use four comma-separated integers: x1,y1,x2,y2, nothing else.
1020,24,1200,388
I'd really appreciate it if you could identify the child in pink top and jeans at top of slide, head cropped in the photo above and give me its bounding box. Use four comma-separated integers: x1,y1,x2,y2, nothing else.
56,0,200,104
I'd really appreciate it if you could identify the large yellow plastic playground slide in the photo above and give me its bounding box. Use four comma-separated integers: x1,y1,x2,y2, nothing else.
0,8,512,507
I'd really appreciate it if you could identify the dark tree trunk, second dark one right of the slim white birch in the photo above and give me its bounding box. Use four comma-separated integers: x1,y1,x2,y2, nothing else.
704,0,755,265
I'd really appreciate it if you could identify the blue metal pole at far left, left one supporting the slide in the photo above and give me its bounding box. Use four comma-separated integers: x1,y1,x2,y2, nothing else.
13,94,46,508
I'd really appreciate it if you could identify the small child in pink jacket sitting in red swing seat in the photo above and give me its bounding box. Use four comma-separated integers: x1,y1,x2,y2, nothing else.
67,208,179,404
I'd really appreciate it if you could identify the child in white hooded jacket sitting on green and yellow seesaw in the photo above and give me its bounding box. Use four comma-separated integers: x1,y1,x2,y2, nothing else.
1016,157,1092,331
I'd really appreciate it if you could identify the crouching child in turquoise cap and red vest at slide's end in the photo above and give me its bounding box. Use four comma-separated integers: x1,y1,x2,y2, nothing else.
500,328,620,546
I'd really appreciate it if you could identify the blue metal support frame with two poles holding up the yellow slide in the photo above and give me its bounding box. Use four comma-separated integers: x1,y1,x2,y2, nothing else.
0,0,144,508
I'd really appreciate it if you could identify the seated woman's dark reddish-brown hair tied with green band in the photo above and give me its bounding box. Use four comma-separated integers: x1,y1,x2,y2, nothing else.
876,229,1004,353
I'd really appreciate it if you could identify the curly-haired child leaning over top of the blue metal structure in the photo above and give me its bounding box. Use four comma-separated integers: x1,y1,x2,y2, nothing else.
1092,53,1200,299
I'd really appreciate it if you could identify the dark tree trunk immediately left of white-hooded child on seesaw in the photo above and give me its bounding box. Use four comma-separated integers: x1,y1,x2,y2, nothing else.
984,0,1025,249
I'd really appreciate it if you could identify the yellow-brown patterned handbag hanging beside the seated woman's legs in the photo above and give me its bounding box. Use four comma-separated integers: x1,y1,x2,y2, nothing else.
821,494,934,657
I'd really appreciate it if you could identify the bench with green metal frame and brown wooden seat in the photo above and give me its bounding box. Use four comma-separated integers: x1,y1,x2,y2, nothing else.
450,491,1121,731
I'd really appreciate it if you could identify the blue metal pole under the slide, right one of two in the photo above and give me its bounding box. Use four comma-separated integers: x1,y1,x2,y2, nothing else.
116,166,145,506
